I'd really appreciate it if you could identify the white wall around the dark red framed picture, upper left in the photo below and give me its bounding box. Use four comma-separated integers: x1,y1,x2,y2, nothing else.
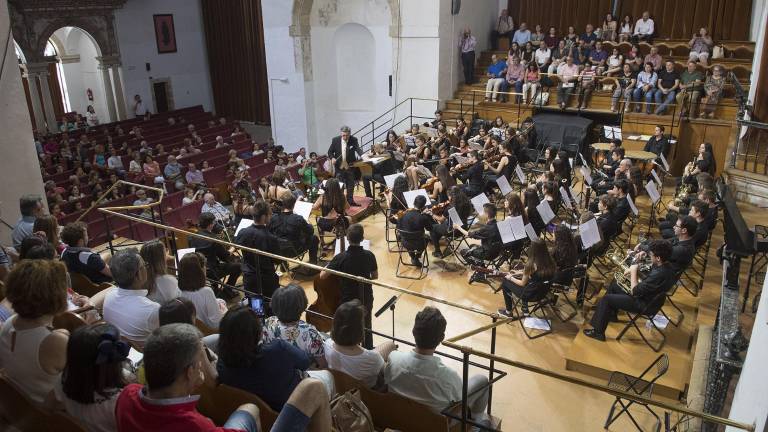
115,0,214,113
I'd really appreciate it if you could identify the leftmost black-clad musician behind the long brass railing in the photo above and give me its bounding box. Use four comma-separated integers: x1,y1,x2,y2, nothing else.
189,212,240,297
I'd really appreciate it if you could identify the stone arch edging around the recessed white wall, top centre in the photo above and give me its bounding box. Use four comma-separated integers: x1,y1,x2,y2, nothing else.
288,0,400,81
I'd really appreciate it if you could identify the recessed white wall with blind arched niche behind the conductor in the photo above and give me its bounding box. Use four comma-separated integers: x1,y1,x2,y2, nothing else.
310,0,396,151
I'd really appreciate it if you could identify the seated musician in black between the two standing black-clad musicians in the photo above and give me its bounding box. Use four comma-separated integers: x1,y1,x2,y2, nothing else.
269,194,320,264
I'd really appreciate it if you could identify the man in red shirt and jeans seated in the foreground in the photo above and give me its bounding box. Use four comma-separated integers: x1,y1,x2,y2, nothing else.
115,324,331,432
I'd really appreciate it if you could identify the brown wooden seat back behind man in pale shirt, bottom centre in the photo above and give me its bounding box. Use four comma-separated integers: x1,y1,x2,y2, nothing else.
330,370,460,431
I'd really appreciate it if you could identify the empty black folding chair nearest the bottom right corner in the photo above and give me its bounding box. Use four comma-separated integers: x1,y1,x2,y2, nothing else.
603,354,669,432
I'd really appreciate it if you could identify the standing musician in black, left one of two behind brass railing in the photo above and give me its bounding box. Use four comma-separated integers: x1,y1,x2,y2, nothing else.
235,199,280,306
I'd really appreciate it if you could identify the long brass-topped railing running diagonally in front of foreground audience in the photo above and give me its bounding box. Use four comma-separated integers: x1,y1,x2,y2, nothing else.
90,198,755,432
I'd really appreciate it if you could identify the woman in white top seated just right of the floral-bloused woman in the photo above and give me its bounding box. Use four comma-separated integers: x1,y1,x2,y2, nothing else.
325,300,397,387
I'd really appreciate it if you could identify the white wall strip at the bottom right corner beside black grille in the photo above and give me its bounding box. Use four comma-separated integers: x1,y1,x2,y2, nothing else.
726,272,768,432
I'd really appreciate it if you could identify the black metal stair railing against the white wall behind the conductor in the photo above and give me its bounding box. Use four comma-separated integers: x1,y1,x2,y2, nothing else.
352,98,440,151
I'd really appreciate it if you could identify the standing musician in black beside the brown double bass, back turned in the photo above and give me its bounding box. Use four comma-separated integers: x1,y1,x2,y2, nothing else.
320,224,379,349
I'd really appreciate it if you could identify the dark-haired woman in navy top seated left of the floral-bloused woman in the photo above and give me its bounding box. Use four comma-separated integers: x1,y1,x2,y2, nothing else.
216,306,333,411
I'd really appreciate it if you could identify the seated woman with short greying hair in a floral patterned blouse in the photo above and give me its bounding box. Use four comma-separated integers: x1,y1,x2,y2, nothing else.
262,284,328,369
